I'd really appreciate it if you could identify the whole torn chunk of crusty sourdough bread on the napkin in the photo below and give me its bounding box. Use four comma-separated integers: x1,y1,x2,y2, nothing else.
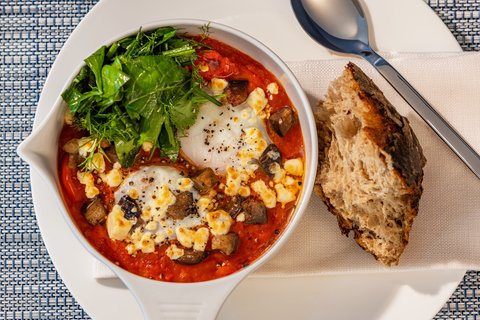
315,63,426,266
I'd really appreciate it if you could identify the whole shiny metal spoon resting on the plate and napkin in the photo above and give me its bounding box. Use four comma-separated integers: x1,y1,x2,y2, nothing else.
291,0,480,179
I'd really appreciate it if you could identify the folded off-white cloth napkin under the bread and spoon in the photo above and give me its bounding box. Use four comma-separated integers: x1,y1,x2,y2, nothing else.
93,53,480,278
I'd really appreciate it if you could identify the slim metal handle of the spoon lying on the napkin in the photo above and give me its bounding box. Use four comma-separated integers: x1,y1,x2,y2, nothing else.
362,50,480,179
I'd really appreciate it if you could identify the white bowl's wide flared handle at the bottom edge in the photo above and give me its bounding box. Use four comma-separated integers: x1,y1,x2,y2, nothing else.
117,270,247,320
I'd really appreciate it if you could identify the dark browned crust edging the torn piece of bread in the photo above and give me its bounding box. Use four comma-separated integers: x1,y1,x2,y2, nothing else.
314,62,426,266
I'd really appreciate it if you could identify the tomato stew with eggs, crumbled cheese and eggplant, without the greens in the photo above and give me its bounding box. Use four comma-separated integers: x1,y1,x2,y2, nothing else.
58,28,305,282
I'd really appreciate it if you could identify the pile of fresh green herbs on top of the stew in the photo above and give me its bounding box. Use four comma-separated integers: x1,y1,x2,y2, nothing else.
62,27,220,169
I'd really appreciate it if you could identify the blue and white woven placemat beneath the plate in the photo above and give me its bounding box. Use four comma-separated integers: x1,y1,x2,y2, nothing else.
0,0,480,320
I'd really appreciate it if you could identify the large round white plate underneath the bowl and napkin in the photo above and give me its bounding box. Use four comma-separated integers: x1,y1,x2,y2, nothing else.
31,0,465,320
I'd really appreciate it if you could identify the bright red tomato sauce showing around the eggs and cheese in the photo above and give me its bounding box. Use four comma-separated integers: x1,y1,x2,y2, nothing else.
58,38,304,282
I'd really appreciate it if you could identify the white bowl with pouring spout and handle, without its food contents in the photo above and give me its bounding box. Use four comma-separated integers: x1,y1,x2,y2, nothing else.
17,19,317,319
